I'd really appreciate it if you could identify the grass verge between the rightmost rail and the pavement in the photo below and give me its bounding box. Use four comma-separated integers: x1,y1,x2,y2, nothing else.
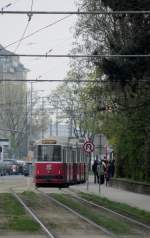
80,192,150,224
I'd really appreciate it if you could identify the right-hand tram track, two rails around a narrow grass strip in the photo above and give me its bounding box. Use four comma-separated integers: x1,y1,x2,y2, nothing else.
39,189,150,238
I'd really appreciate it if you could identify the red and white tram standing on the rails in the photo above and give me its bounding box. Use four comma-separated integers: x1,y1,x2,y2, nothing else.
34,139,87,187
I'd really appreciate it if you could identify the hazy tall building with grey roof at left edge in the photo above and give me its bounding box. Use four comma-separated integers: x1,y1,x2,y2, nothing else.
0,45,29,158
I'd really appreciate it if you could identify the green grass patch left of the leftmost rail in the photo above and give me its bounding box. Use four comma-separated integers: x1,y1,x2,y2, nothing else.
0,194,40,232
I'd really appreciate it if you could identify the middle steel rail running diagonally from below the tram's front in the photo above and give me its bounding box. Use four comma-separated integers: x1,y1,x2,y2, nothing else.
37,189,116,238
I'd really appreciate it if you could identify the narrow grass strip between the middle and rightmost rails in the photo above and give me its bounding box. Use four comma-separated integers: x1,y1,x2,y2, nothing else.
53,194,130,234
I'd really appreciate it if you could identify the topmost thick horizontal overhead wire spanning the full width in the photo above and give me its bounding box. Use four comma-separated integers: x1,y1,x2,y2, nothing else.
0,10,150,16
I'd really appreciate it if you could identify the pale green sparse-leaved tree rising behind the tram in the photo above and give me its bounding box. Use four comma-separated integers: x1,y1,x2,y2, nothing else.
47,69,104,140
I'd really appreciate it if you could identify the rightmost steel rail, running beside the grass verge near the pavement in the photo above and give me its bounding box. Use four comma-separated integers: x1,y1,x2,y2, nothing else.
68,189,150,230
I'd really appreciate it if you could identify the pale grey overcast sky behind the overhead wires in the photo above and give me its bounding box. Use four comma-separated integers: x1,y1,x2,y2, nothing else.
0,0,76,95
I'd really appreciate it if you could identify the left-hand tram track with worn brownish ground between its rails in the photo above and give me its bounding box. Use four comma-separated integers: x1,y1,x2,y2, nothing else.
11,190,111,238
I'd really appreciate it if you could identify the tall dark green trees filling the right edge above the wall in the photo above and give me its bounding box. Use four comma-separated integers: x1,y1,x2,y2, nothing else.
73,0,150,181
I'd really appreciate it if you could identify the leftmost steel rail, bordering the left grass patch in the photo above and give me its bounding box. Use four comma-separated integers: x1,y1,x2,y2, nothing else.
10,189,56,238
